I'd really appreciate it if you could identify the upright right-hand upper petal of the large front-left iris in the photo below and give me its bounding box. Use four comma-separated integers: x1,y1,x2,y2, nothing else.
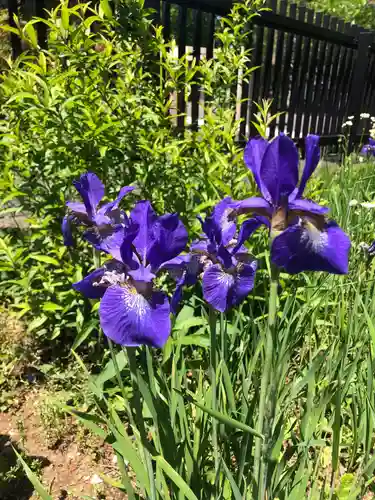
147,214,188,272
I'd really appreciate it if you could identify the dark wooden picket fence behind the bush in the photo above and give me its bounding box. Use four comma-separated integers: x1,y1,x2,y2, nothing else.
4,0,375,145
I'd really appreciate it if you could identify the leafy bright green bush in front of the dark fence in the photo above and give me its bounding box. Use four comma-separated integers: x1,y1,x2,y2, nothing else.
0,0,262,347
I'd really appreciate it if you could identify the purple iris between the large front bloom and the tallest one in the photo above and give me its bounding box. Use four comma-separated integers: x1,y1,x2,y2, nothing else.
163,198,262,312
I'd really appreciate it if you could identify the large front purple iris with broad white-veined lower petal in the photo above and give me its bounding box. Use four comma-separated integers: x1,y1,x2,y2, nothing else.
73,201,188,347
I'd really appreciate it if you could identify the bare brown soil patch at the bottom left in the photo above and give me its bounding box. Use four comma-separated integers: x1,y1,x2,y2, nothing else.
0,390,127,500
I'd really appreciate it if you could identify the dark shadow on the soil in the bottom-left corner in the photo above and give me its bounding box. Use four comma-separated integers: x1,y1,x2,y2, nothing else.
0,434,50,500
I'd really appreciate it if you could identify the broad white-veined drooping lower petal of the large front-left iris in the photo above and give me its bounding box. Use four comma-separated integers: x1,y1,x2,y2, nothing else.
99,286,171,347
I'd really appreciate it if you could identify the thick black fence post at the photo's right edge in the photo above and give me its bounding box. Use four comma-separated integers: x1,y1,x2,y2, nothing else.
347,31,374,152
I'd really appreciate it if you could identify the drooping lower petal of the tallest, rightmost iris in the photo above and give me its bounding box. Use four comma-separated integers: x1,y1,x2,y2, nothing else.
271,221,350,274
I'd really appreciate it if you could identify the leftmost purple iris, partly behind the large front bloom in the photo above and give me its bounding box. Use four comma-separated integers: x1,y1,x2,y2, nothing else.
62,172,134,253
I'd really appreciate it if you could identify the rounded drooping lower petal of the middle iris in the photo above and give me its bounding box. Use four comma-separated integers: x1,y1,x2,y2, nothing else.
202,261,256,312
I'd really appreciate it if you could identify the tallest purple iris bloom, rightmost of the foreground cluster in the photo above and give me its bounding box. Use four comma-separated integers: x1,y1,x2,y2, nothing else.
236,134,350,274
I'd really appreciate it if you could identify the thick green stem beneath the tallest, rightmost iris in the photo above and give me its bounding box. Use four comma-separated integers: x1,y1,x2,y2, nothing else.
254,264,279,500
